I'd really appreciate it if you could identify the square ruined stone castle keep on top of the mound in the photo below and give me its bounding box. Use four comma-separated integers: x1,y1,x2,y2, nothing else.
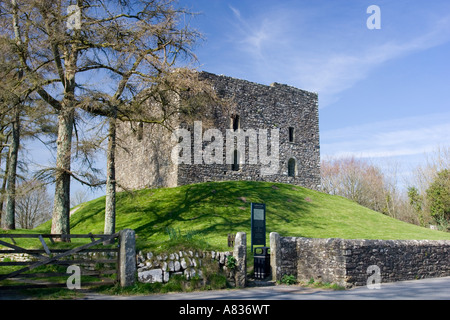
116,72,320,189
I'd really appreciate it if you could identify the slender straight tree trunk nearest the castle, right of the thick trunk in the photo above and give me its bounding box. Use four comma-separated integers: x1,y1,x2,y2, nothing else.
104,114,116,239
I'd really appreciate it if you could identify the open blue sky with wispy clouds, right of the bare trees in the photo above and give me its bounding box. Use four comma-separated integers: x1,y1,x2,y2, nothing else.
180,0,450,184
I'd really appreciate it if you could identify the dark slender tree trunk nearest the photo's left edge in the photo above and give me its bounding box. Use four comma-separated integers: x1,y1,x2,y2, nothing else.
2,105,20,230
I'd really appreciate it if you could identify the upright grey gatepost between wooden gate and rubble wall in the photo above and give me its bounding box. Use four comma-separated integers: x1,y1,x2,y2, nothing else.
118,229,136,287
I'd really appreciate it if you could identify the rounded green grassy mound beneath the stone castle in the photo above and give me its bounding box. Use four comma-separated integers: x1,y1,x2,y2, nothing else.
29,181,450,249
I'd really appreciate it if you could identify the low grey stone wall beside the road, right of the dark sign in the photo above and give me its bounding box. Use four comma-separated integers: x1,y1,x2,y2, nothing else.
271,233,450,287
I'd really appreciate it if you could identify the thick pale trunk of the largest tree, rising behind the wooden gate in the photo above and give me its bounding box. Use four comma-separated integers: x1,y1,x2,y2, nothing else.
51,105,75,234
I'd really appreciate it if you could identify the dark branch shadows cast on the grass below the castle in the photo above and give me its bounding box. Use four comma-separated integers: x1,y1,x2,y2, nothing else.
118,181,320,244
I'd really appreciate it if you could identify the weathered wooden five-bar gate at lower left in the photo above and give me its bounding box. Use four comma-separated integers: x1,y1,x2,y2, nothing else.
0,233,119,290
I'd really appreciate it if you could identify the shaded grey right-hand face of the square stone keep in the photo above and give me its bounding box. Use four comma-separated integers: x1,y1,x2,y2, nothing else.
178,72,320,189
